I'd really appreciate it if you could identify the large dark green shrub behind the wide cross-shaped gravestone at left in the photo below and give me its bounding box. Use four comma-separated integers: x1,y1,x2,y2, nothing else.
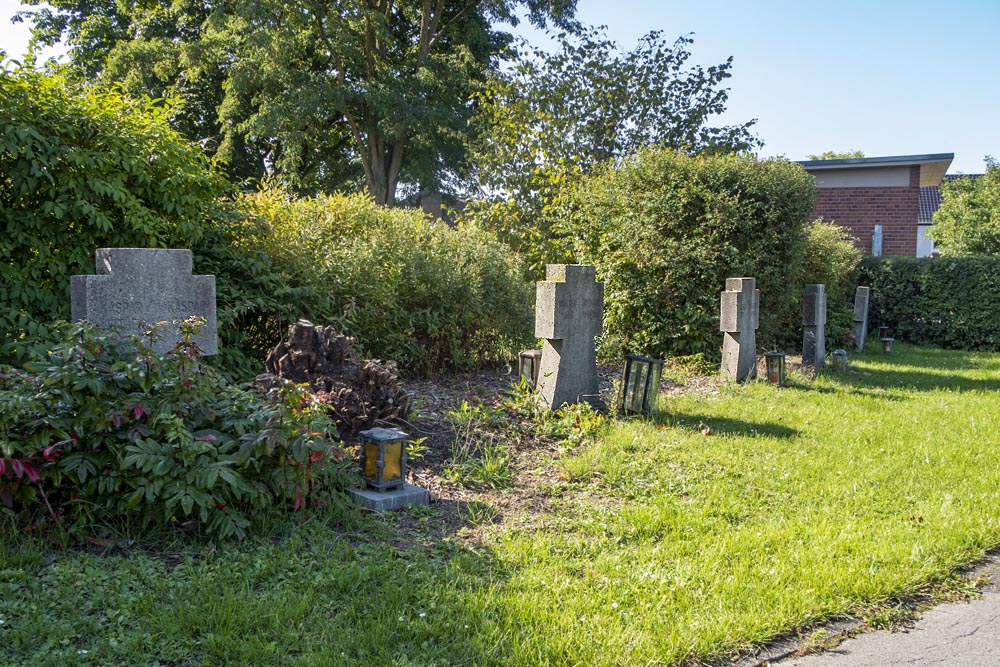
0,68,298,377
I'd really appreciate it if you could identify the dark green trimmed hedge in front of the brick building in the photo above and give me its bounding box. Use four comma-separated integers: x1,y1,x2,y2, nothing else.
859,257,1000,351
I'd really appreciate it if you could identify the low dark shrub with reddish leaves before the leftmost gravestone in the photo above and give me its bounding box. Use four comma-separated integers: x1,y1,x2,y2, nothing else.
0,324,349,537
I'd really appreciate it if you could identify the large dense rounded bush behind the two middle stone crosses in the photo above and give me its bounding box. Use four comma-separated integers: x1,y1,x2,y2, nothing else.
557,148,814,359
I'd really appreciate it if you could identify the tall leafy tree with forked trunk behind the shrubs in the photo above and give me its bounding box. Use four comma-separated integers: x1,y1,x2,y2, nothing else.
25,0,576,205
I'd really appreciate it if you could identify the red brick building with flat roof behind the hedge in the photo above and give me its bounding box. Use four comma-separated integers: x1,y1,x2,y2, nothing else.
799,153,955,257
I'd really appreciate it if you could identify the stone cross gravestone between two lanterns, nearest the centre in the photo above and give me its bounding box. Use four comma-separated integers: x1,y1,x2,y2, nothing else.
535,264,604,409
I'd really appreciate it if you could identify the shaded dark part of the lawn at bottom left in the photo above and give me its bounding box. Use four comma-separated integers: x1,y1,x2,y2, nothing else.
0,506,511,667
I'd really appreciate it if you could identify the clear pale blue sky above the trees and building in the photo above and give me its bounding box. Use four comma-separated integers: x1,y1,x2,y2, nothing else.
0,0,1000,173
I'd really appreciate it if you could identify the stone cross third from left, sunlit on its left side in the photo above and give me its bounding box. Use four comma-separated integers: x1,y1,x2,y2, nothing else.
719,278,760,382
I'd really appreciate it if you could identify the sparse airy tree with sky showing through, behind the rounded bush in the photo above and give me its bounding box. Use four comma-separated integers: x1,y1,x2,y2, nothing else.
470,28,759,279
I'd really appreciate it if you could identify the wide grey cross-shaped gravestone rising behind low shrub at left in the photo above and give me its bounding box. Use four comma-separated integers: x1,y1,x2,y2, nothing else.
70,248,219,354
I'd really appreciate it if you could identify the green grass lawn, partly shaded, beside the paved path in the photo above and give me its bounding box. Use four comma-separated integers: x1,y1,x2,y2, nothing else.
0,345,1000,667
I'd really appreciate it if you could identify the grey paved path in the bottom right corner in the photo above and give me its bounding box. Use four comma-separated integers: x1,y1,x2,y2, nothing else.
761,562,1000,667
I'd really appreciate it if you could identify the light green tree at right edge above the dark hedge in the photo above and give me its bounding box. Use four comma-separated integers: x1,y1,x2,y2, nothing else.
928,156,1000,255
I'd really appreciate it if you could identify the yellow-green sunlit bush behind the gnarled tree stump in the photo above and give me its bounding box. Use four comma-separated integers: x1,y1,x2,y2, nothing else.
246,190,531,373
